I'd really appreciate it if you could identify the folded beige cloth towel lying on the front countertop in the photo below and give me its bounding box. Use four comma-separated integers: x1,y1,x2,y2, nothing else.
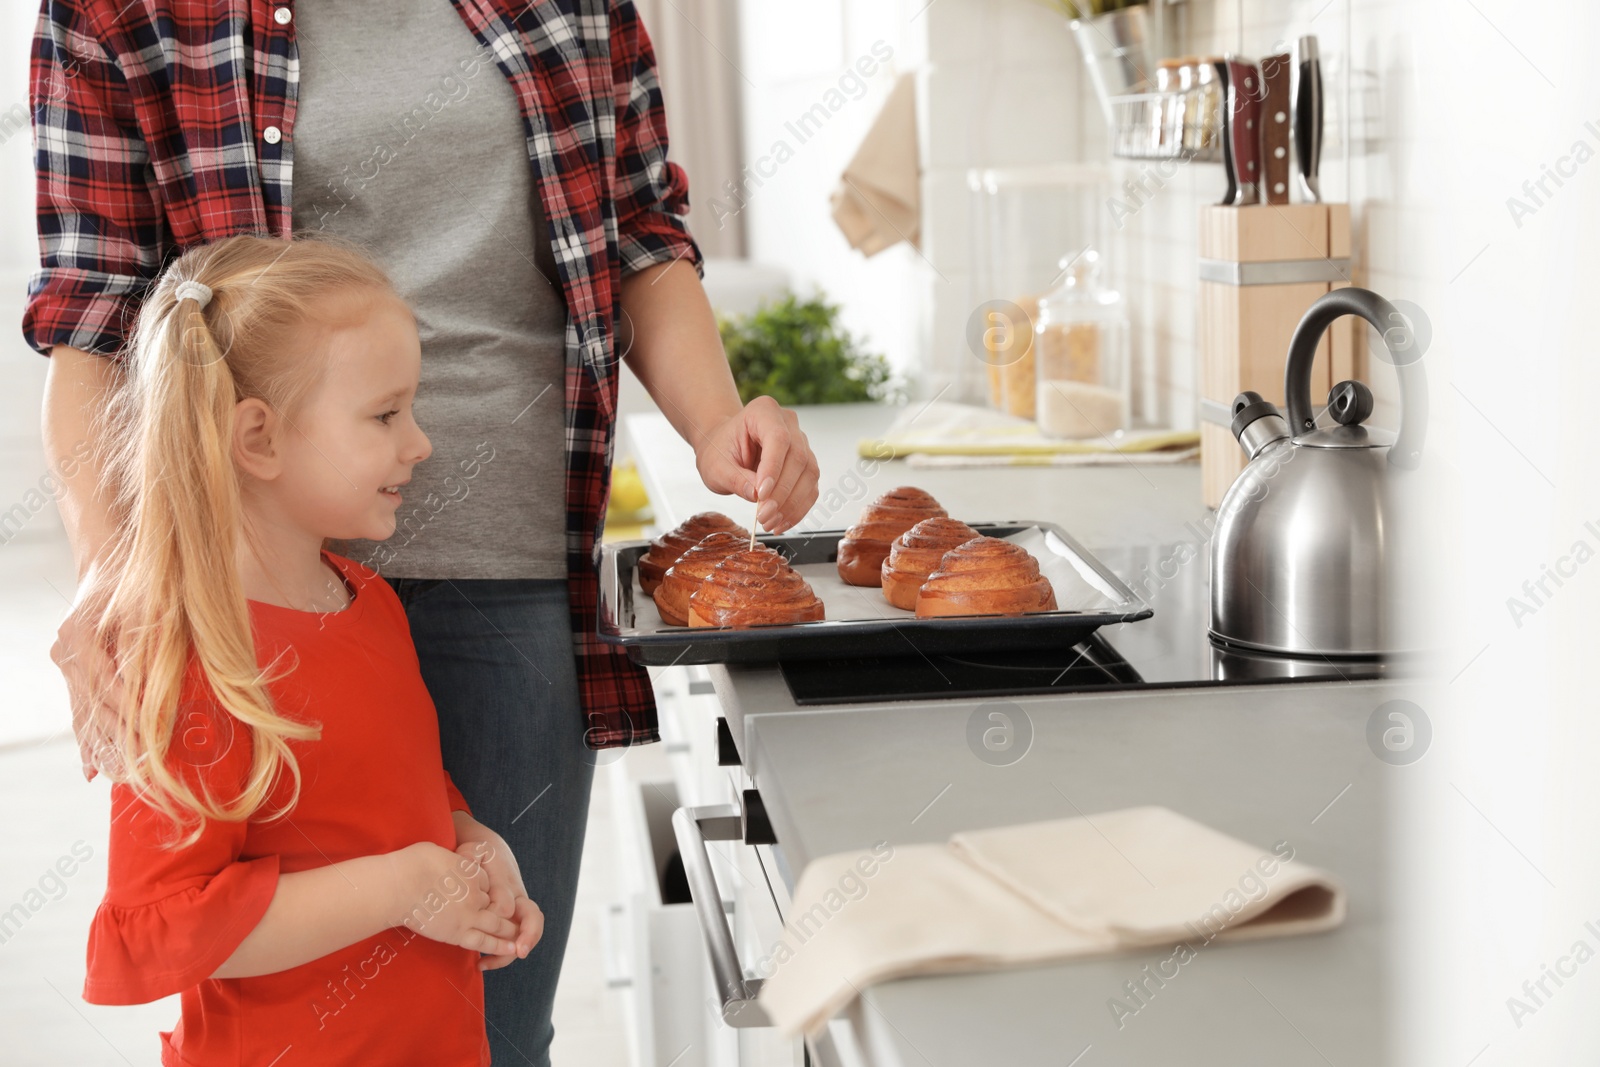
760,806,1346,1035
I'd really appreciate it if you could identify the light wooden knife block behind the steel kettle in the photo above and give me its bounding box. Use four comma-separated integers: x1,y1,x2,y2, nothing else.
1198,203,1360,507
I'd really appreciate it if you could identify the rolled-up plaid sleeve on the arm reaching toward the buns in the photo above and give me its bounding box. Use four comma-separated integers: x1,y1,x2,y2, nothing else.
611,0,706,277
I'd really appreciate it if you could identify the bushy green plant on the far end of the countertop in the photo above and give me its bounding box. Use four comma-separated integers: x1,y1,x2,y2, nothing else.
717,293,902,406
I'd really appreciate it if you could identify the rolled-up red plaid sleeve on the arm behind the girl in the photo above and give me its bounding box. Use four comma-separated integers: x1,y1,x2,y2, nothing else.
22,0,163,355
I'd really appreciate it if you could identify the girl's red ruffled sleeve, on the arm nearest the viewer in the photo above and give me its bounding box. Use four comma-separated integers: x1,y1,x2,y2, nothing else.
83,704,278,1005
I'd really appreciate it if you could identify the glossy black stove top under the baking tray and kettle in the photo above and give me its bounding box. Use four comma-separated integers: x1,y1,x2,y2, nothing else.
779,542,1392,705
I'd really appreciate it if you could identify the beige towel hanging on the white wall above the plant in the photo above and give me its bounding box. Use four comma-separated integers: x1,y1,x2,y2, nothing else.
829,74,922,256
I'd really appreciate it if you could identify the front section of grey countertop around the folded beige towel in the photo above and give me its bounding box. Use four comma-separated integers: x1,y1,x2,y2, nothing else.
746,681,1403,1067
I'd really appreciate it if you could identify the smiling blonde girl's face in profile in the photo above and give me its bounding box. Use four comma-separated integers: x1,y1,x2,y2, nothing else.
259,294,434,541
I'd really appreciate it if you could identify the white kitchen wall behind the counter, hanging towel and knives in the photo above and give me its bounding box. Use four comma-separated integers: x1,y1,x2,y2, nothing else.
732,0,1403,427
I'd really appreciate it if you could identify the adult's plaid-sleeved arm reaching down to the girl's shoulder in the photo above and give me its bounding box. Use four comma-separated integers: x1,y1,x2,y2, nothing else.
22,2,170,779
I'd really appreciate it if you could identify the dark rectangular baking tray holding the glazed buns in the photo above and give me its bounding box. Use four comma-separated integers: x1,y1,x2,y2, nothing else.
598,522,1155,667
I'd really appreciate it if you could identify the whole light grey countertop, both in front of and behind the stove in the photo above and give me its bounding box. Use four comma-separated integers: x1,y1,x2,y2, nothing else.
629,405,1405,1067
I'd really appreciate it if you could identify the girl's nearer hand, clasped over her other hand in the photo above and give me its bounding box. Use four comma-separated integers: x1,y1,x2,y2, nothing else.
398,841,518,957
